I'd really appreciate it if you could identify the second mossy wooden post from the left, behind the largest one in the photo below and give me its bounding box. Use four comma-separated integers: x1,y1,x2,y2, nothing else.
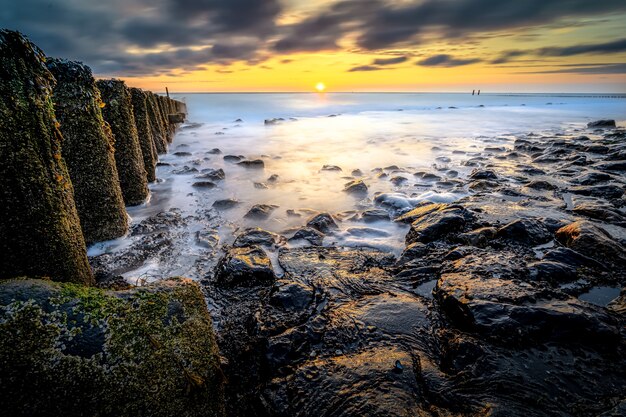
47,59,128,244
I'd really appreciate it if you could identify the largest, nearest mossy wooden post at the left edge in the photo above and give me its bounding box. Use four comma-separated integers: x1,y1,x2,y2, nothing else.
0,30,94,285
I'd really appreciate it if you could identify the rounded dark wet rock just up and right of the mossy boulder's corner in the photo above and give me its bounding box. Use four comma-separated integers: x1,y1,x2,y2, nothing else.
215,246,275,287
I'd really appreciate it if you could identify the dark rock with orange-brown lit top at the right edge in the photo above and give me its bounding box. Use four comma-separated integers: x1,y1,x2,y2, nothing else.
556,220,626,265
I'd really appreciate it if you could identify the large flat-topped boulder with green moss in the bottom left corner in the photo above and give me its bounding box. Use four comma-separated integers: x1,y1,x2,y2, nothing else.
0,278,223,417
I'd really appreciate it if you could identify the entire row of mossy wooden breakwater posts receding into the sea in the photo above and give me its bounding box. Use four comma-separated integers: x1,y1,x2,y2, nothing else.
0,30,186,285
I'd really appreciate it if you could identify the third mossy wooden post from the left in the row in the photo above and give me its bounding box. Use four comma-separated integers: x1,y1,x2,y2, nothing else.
96,79,148,206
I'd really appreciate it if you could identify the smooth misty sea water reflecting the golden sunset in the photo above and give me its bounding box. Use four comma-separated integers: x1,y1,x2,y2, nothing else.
90,93,626,272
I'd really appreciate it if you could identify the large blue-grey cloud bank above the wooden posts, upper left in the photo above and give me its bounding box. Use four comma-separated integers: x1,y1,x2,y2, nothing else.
0,0,281,76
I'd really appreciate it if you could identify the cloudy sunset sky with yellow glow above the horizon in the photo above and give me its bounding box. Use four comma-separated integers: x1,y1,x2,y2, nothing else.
0,0,626,93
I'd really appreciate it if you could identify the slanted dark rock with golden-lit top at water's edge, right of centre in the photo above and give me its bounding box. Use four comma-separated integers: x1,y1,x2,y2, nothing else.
405,206,473,244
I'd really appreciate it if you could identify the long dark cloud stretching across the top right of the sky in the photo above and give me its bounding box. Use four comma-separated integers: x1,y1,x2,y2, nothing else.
276,0,626,51
